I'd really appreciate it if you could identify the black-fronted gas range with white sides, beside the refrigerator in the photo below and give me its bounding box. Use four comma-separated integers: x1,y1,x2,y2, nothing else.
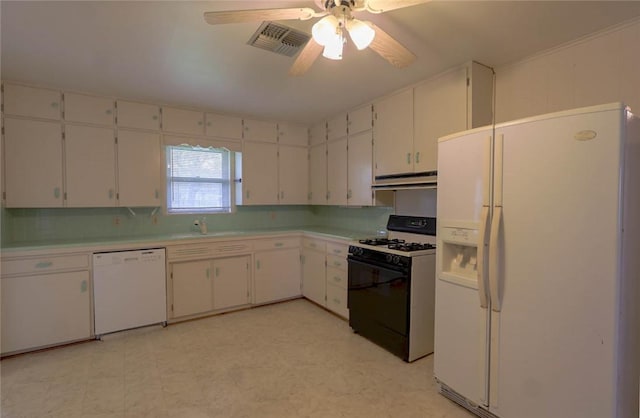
347,215,436,362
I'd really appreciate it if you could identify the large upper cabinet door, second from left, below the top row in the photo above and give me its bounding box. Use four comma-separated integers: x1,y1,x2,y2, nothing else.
65,125,116,207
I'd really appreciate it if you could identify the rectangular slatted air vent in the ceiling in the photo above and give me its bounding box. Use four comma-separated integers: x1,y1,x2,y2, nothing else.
247,22,311,57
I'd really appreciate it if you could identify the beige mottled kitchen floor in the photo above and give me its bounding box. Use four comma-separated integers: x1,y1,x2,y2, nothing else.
0,299,472,418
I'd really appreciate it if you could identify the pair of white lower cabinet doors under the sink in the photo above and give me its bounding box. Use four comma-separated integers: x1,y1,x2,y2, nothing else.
170,255,250,318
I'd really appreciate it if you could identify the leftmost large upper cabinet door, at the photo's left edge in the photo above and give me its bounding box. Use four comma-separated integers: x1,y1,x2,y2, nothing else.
4,117,63,208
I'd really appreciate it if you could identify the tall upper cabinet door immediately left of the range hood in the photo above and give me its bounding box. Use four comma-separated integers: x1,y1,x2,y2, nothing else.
347,131,373,206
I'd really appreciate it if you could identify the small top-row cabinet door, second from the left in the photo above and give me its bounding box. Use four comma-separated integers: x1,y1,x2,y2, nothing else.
64,93,115,126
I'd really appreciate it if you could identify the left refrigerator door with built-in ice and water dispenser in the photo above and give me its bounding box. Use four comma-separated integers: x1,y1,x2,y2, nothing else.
434,125,492,405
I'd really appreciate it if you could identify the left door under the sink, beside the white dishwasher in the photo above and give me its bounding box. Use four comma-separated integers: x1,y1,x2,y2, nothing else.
171,260,213,318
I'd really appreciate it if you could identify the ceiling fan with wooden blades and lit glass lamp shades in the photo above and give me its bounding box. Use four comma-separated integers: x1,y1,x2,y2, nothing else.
204,0,430,75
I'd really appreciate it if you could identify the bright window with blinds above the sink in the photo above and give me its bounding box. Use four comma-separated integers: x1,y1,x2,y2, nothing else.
167,146,232,213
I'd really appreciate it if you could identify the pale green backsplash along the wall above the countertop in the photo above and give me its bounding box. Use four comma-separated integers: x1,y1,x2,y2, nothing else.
0,206,392,246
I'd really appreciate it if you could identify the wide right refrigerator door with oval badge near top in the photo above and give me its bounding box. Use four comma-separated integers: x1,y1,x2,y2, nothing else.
490,109,623,418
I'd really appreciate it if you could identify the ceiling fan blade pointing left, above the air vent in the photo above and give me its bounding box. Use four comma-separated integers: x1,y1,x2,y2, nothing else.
204,7,326,25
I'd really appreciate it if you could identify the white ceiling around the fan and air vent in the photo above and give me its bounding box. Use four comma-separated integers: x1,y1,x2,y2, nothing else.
0,0,640,123
